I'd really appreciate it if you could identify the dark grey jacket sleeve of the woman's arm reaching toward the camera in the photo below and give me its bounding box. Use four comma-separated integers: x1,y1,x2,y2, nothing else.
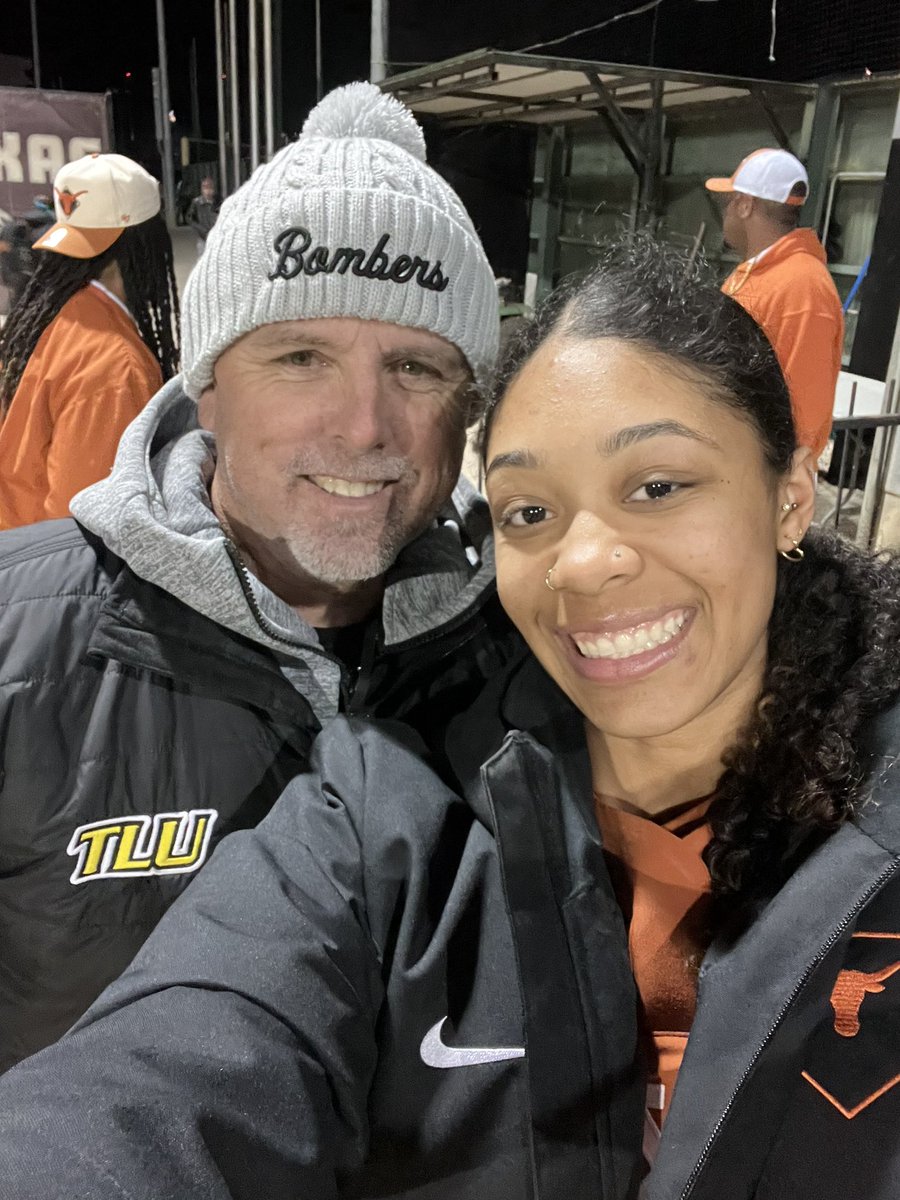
0,726,383,1200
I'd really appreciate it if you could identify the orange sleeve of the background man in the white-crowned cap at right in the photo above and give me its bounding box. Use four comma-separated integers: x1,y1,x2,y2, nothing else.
778,307,842,457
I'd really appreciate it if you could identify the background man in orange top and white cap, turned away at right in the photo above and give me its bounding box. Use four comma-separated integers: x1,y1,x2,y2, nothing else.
706,150,844,456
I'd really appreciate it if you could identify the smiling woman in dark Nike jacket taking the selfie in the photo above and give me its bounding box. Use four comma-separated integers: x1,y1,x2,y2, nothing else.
0,236,900,1200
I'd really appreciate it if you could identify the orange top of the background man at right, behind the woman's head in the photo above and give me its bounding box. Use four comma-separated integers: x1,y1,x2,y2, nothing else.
722,229,844,456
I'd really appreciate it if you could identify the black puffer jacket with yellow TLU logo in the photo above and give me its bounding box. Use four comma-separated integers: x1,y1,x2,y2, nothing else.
0,521,515,1069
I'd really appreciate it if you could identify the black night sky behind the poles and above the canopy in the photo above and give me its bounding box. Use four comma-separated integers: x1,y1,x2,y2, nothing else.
0,0,900,182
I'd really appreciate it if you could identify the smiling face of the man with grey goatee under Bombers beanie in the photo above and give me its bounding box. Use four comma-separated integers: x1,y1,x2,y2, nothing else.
199,317,469,588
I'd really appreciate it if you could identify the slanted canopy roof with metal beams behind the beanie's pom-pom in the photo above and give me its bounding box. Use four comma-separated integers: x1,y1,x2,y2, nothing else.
380,50,816,140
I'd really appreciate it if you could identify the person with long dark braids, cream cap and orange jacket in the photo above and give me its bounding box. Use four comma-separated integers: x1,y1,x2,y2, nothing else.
0,154,179,529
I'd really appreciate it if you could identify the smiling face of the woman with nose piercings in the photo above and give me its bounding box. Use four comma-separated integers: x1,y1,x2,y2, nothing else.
486,335,811,740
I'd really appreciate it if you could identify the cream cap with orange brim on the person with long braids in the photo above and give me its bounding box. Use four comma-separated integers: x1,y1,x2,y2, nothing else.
32,154,161,258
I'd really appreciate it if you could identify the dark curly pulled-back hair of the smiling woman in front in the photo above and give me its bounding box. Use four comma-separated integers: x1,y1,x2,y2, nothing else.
481,235,900,919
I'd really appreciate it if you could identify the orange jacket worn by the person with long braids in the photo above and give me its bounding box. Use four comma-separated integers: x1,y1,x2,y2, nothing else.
0,284,162,529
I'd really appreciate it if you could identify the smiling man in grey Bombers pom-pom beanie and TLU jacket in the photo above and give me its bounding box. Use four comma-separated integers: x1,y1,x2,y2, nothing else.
0,84,512,1068
